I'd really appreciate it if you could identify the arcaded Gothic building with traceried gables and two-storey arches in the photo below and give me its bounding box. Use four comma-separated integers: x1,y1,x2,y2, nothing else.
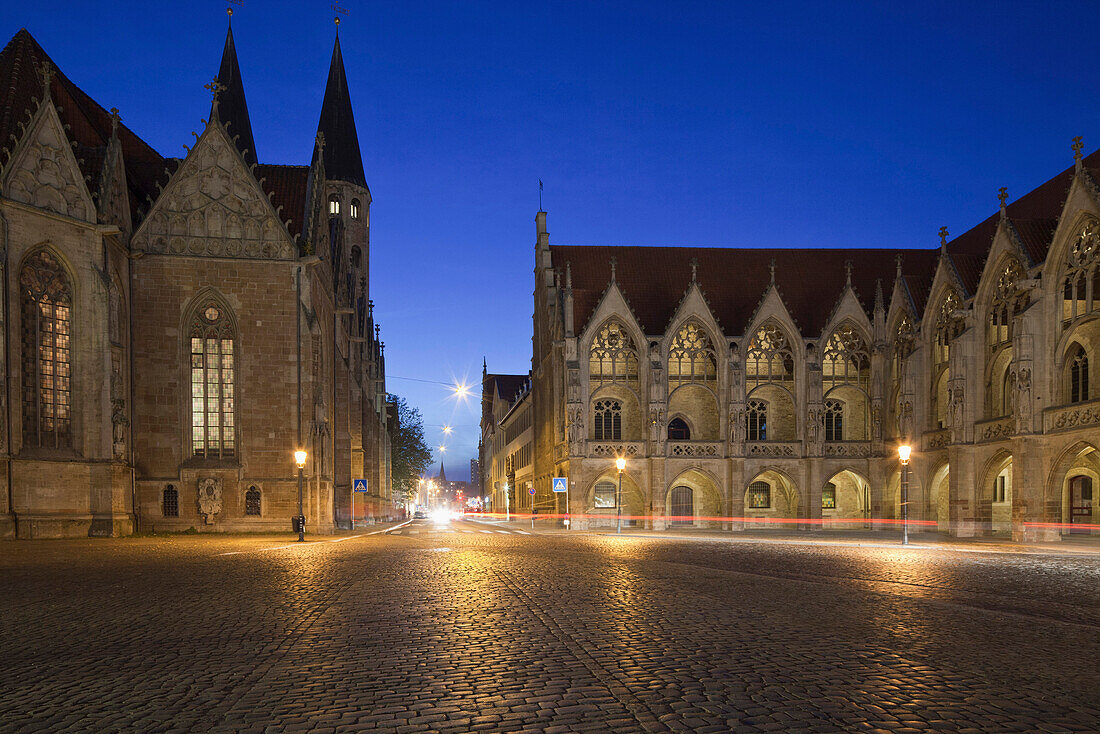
521,146,1100,539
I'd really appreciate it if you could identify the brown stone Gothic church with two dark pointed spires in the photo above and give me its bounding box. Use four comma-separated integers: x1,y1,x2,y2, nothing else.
0,29,391,537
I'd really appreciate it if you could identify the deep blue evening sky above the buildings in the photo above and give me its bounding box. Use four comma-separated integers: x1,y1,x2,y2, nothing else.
0,0,1100,479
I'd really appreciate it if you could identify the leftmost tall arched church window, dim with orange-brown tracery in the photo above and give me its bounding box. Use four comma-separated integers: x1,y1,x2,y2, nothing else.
19,250,73,449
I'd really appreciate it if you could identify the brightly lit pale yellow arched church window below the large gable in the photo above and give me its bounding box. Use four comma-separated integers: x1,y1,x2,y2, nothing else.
190,300,237,458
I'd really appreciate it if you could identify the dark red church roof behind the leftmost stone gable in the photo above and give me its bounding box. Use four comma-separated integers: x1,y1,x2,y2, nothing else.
0,29,167,224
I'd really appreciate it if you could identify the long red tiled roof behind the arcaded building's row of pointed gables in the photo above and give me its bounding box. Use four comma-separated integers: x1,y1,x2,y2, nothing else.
550,245,937,336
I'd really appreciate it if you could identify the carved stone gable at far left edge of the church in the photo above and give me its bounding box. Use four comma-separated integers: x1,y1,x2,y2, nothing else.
3,99,96,221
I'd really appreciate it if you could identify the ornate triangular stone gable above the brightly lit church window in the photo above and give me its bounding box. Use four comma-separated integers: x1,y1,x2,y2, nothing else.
131,121,296,260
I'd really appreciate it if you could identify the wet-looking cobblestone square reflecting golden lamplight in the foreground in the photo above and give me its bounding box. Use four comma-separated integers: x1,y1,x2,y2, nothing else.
0,521,1100,733
